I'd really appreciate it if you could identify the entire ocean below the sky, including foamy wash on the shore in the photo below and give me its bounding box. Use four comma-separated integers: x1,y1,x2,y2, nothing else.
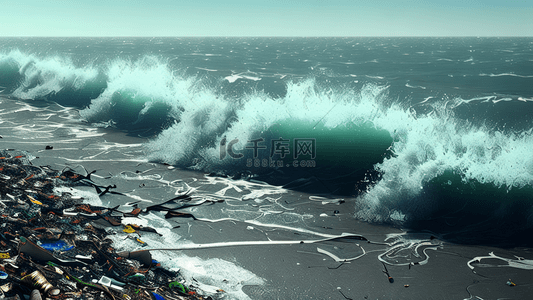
0,37,533,299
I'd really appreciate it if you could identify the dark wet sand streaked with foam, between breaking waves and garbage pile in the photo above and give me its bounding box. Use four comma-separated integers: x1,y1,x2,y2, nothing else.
0,96,533,300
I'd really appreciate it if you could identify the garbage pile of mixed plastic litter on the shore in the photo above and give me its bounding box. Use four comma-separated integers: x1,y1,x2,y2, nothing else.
0,151,212,300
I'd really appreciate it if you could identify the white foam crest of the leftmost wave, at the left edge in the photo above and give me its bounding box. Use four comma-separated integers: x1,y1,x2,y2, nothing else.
4,50,98,99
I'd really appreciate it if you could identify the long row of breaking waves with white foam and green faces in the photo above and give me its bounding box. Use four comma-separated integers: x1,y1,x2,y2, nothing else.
0,51,533,244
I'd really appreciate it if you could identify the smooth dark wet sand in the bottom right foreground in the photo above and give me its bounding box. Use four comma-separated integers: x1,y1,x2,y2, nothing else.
183,210,533,299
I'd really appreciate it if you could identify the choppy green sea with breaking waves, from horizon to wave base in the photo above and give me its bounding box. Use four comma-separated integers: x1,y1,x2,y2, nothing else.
0,37,533,298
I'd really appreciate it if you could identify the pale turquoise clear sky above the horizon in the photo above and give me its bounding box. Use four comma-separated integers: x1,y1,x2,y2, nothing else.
0,0,533,36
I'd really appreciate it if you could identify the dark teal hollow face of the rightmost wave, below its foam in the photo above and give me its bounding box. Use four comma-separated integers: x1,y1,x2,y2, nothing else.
410,170,533,246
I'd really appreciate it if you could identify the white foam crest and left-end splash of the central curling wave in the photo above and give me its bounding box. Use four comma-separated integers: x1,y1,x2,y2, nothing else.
147,80,385,171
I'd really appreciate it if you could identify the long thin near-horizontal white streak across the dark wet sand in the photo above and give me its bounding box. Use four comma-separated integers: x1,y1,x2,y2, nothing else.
146,233,361,251
